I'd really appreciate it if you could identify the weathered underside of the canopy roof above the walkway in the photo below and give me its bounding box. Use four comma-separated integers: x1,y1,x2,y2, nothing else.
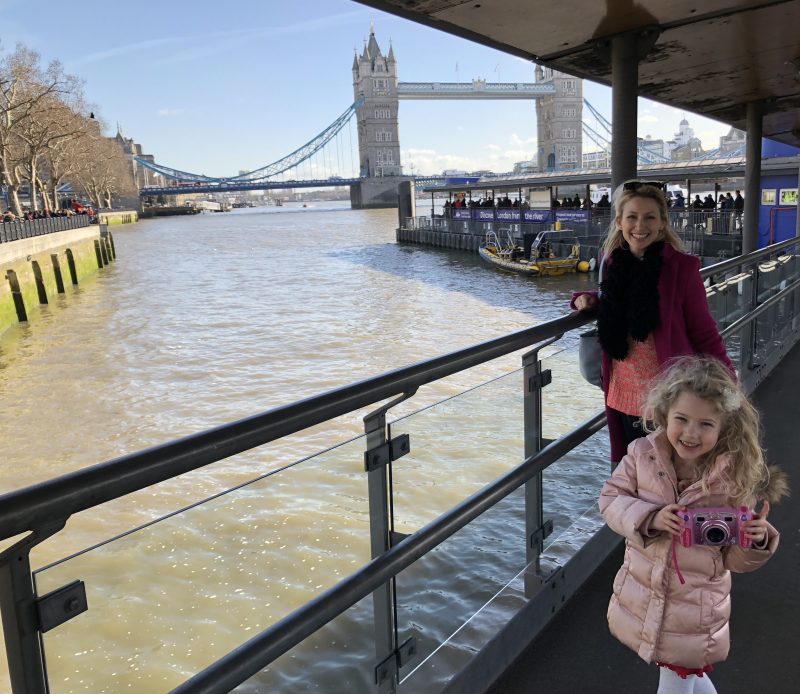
358,0,800,146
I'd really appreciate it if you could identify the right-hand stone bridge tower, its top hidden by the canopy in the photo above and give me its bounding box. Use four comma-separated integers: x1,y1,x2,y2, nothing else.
536,65,583,171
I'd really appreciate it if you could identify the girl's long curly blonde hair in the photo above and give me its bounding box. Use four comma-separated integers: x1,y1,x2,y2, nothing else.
643,356,788,506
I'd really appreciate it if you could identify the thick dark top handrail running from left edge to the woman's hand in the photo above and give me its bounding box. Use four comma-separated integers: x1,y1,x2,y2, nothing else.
0,313,594,540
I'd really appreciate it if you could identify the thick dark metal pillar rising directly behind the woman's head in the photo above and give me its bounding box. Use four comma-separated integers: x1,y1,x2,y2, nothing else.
611,33,639,190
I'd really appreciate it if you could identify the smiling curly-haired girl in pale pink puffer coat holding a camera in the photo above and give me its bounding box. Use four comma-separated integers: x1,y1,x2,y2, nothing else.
600,356,788,694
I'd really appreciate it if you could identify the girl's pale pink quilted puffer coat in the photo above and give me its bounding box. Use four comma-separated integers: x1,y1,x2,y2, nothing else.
600,430,779,668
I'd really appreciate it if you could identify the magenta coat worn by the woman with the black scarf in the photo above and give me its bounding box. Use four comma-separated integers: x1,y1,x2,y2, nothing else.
570,244,736,461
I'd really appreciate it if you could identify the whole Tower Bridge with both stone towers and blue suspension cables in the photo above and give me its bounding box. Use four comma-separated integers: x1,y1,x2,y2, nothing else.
134,28,716,208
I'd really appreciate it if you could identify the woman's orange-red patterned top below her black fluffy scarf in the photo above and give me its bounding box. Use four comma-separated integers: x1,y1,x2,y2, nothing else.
606,333,659,417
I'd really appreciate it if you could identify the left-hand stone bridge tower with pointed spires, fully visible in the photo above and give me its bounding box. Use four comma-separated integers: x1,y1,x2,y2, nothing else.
351,27,404,207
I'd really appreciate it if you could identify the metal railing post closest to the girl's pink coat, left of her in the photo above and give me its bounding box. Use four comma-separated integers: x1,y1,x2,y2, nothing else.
522,335,561,598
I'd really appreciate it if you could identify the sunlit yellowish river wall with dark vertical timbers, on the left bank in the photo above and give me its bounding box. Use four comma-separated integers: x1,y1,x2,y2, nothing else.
0,226,116,334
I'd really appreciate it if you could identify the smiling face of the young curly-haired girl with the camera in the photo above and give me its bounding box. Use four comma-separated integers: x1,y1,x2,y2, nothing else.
667,393,722,462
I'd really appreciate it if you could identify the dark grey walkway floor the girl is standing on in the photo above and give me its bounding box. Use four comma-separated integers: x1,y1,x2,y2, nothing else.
482,345,800,694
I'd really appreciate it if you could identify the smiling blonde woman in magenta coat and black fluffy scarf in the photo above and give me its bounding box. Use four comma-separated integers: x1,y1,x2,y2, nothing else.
571,181,735,463
